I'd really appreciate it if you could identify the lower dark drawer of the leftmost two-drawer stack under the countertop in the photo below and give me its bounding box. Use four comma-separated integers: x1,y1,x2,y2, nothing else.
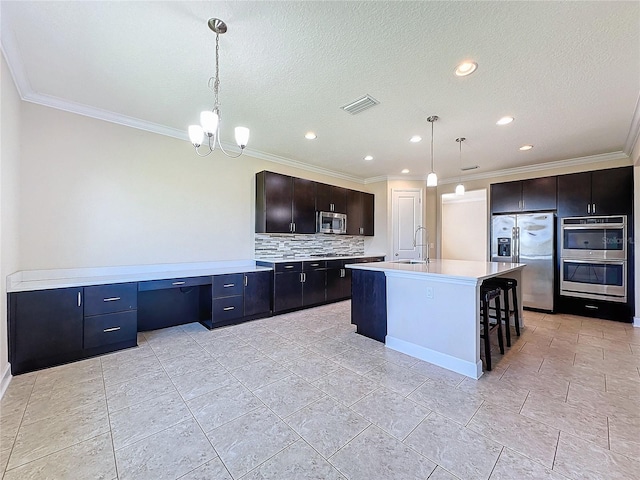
84,310,138,349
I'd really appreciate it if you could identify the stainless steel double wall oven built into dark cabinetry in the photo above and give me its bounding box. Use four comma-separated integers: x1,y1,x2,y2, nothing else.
560,215,627,303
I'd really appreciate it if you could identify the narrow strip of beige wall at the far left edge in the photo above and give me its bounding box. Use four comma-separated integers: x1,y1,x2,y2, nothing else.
0,52,20,388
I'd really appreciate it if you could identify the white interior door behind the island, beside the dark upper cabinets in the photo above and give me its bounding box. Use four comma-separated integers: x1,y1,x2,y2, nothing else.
391,189,422,259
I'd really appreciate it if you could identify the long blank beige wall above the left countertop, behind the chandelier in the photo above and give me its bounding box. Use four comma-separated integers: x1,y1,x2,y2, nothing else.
20,103,370,270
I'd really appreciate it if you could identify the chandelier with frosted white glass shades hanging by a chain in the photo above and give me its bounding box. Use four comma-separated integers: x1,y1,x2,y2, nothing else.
189,18,249,158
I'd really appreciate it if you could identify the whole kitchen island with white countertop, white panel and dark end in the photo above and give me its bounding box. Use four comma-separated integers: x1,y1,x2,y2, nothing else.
348,260,525,378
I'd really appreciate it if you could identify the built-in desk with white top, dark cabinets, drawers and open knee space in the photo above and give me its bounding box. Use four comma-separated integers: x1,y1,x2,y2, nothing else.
7,261,272,375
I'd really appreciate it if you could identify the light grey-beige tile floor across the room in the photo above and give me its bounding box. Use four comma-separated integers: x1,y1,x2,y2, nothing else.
0,302,640,480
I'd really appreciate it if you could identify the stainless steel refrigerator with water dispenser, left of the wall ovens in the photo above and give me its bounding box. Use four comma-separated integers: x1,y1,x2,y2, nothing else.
491,212,555,311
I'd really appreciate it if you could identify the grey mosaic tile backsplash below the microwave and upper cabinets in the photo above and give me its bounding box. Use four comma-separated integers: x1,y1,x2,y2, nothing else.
255,233,364,258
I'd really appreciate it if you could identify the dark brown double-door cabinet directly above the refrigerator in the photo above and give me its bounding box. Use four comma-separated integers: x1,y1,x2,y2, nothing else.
491,177,557,213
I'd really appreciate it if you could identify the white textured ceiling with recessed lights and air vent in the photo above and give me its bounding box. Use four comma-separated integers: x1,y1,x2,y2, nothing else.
0,0,640,183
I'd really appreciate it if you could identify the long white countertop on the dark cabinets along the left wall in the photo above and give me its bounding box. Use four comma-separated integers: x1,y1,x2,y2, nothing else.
7,260,271,293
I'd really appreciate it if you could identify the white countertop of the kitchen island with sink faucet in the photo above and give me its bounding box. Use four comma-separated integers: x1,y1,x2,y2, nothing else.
348,259,525,281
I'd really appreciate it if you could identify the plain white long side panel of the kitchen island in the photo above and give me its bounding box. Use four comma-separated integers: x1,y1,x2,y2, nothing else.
385,272,482,378
